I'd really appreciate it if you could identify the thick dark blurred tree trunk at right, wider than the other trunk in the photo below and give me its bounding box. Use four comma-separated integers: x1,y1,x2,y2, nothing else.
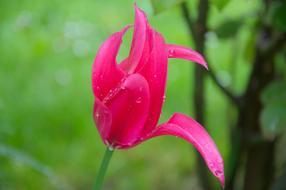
239,27,282,190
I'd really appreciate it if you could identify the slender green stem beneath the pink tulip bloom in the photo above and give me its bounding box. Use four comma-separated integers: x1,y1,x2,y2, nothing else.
93,147,114,190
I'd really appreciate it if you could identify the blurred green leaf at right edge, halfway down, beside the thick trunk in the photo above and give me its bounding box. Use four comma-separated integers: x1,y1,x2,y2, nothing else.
260,80,286,139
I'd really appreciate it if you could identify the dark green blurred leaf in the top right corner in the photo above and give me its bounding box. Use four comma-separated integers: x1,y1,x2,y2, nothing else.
270,2,286,32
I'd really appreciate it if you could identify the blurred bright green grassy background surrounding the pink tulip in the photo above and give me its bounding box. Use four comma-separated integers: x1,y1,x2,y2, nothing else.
0,0,284,190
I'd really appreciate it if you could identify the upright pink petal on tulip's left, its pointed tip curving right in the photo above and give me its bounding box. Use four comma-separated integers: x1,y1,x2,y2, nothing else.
92,26,130,100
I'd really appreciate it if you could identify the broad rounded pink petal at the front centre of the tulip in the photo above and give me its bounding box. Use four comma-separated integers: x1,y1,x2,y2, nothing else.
103,74,150,148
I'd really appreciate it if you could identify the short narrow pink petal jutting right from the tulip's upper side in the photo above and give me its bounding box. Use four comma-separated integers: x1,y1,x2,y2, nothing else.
167,44,208,69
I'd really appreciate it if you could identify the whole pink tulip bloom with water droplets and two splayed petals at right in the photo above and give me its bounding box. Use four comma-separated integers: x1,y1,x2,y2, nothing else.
92,5,224,185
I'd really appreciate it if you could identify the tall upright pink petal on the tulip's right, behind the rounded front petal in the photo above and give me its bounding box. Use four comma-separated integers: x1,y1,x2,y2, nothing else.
138,28,168,135
